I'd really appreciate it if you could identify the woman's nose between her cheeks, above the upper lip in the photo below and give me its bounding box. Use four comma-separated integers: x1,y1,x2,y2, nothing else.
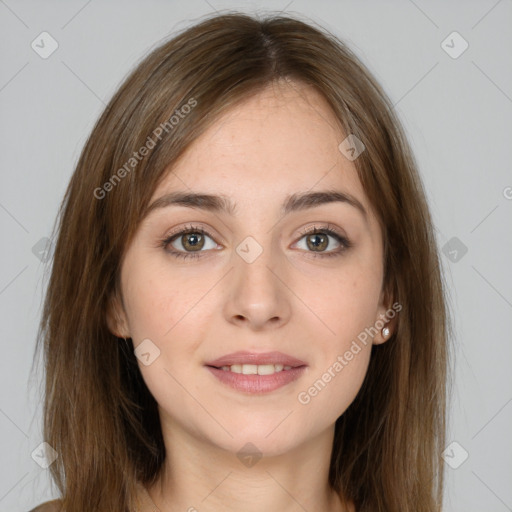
224,244,291,331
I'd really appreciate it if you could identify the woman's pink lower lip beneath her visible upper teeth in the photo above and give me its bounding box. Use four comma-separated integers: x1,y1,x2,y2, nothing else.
206,366,306,393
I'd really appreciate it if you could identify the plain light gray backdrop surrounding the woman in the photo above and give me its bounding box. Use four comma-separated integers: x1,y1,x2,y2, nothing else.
0,0,512,512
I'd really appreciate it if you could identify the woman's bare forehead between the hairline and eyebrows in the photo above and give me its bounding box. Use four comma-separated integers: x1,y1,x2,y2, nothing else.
152,82,371,214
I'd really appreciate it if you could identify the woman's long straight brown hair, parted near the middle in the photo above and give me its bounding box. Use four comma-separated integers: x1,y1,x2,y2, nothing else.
32,12,449,512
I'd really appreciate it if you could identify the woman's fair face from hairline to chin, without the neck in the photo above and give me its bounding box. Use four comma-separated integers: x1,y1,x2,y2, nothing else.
109,83,389,455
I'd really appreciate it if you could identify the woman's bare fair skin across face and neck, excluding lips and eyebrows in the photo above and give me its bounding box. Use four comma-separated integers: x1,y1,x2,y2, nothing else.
109,78,393,512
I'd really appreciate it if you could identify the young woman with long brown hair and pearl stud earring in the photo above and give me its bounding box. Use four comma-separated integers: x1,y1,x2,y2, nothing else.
32,9,448,512
